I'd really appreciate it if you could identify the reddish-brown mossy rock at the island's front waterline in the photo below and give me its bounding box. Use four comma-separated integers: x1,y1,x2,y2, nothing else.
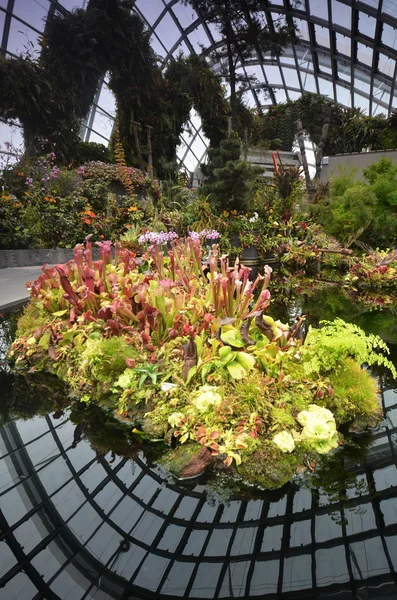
160,444,213,479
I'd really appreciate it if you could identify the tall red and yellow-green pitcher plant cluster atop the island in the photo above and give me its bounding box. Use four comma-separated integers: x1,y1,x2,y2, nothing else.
31,237,271,345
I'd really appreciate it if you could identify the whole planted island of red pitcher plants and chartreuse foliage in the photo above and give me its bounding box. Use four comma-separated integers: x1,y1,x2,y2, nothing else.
9,237,396,488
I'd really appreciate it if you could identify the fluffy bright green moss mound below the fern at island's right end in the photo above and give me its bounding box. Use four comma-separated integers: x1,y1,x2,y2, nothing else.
327,358,380,423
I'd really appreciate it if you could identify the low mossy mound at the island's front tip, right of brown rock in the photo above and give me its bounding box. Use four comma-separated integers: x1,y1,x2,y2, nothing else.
238,442,299,489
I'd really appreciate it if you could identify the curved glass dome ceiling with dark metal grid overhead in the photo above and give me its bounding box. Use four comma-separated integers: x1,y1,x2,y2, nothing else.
0,0,397,172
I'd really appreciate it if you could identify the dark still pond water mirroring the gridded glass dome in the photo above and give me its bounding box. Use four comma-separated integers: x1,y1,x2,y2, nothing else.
0,288,397,600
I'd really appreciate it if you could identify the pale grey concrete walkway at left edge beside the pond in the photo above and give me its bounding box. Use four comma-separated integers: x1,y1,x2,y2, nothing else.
0,267,41,312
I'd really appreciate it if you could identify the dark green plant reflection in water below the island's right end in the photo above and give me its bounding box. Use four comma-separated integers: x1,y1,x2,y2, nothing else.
302,434,376,525
